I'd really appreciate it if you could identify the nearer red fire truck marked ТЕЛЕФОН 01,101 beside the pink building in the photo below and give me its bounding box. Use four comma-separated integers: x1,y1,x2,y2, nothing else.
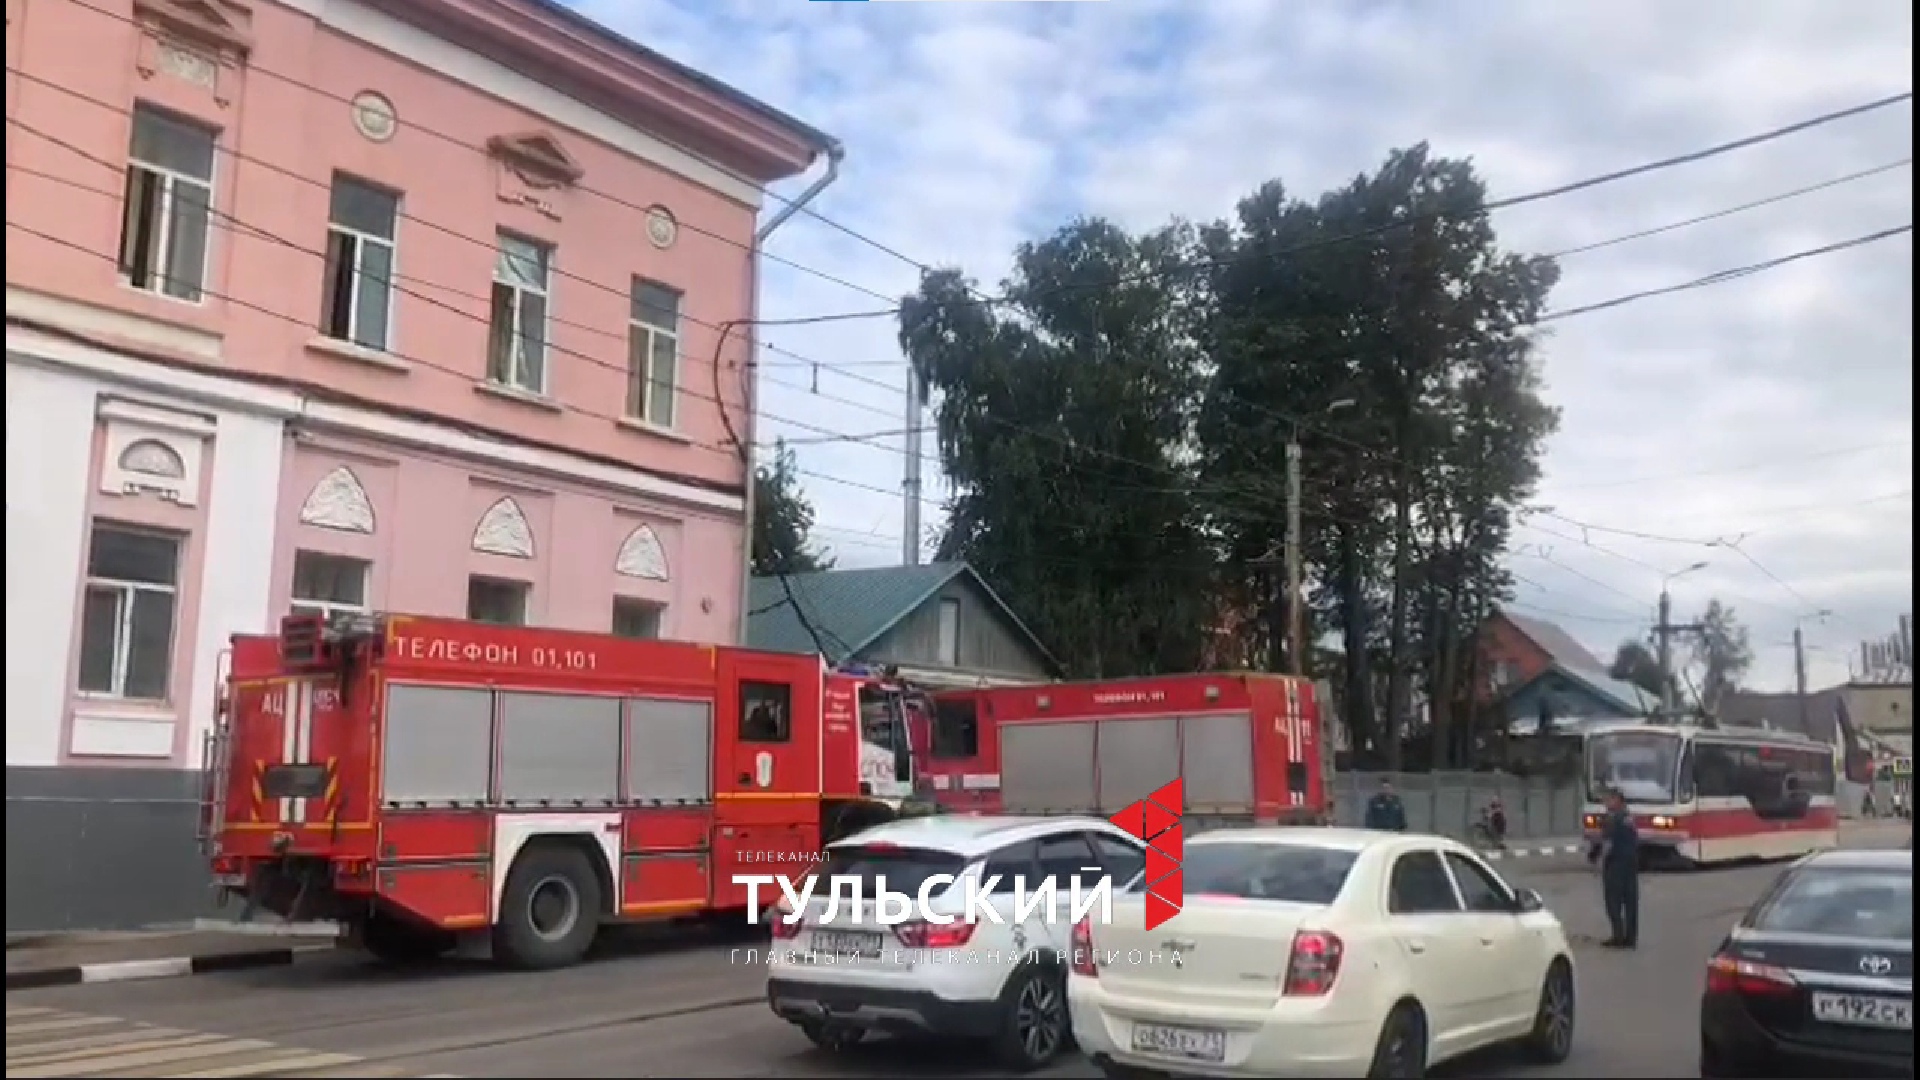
202,615,914,967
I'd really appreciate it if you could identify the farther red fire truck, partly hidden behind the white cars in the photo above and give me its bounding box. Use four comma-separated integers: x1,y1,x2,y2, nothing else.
916,673,1332,824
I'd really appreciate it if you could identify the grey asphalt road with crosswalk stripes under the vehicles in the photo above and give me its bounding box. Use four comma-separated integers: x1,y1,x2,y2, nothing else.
6,818,1905,1078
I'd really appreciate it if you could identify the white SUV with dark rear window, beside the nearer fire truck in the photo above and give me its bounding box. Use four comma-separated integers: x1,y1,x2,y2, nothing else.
766,817,1146,1070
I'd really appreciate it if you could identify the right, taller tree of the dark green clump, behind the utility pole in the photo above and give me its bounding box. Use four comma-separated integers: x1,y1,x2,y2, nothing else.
1196,146,1559,767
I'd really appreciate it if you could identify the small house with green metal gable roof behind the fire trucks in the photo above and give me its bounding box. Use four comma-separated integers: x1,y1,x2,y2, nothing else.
747,563,1060,686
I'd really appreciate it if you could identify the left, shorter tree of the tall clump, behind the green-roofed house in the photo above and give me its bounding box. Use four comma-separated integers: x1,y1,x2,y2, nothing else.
900,219,1219,676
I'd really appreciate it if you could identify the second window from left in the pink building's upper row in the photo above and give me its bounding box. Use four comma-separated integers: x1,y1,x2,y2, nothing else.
321,175,399,350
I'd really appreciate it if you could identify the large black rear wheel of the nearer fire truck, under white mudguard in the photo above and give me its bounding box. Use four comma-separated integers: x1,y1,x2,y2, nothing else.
493,842,601,969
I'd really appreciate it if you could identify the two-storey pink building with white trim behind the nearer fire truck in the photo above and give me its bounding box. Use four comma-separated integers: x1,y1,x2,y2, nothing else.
6,0,839,930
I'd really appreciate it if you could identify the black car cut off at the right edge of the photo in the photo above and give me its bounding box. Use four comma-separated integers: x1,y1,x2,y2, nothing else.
1699,851,1914,1076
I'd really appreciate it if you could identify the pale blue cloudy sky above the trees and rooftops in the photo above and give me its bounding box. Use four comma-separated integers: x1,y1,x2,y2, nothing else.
576,0,1914,688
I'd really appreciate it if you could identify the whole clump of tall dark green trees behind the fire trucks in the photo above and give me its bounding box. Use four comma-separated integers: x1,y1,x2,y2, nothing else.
900,146,1559,765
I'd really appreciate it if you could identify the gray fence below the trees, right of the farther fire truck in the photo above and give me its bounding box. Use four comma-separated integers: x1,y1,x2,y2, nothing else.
1334,773,1586,842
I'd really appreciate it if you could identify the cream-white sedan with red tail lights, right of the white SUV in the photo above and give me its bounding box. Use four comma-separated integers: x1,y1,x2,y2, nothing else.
1068,828,1574,1076
